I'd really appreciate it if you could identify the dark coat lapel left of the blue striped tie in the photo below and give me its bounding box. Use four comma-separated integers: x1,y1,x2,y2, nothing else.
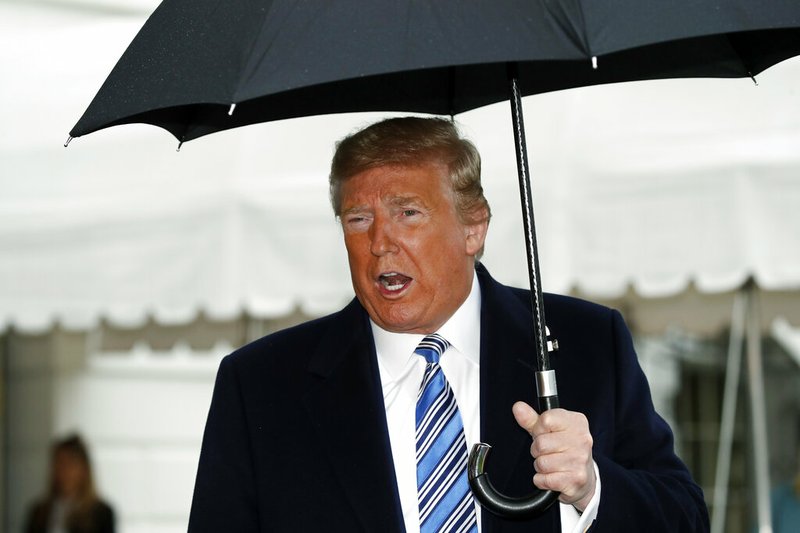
305,301,404,531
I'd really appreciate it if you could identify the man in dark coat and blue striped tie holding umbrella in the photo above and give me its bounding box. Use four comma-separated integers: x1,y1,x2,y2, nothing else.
189,118,708,532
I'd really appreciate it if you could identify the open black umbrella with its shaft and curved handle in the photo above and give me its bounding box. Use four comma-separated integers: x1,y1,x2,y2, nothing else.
70,0,800,515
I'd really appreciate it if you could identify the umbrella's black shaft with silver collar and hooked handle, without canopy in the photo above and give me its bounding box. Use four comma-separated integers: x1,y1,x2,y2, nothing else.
467,63,559,517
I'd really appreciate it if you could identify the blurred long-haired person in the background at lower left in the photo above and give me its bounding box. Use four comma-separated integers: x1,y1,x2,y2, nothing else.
24,435,115,533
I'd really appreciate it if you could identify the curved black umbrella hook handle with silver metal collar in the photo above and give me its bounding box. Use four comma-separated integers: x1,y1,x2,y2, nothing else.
467,366,559,518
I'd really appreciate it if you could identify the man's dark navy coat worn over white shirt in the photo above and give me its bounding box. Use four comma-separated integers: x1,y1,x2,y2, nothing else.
189,265,708,533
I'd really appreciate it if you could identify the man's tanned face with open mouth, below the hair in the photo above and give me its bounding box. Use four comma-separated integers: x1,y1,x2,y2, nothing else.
341,163,488,334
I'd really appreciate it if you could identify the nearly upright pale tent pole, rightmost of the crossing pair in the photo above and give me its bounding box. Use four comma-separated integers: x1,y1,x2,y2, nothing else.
747,281,772,533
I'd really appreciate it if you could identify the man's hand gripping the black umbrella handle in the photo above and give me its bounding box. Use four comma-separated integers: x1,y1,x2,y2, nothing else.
512,402,596,512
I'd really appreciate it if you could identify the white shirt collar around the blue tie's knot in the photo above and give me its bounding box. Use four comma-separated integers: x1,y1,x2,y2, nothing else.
370,273,481,381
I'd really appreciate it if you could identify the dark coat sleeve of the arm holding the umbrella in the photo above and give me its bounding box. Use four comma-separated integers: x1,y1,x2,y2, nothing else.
592,311,709,533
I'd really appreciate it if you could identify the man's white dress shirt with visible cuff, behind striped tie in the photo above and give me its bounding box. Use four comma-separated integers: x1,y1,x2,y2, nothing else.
370,275,600,533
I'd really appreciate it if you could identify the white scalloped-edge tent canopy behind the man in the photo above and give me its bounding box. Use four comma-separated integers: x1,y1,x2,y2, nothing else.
0,0,800,330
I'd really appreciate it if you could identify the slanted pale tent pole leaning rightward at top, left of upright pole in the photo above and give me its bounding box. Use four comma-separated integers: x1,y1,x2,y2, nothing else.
711,289,747,533
